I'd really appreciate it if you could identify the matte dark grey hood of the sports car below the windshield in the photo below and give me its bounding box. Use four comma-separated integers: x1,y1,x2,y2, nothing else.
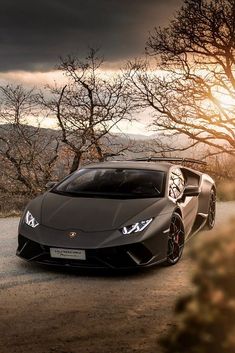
40,192,165,232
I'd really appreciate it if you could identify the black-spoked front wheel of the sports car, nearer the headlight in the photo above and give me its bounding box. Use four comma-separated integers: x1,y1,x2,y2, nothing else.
165,213,184,266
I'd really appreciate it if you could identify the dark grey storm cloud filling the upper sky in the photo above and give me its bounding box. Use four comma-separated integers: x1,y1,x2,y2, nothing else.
0,0,182,71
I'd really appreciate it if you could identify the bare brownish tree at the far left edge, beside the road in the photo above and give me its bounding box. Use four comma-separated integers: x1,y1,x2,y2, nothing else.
0,85,59,194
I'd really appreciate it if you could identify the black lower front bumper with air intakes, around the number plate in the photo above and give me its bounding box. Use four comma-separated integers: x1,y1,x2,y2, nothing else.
16,234,167,269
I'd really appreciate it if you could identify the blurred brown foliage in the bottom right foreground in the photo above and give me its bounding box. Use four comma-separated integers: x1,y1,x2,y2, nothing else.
161,219,235,353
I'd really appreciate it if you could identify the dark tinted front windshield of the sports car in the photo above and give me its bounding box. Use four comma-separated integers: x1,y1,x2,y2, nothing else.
52,168,165,198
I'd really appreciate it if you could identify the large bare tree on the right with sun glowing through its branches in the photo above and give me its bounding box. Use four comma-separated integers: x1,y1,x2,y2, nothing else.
129,0,235,155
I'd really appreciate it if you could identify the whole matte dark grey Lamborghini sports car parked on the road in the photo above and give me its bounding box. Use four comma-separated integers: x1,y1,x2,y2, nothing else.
17,158,216,268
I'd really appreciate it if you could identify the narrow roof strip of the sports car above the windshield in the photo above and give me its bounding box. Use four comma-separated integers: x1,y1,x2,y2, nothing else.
82,161,180,172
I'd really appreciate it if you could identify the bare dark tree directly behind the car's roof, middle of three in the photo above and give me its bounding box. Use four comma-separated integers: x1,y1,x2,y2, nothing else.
41,49,133,172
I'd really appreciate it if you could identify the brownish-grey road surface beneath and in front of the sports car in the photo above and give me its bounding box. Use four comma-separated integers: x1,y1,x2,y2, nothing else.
0,202,235,353
